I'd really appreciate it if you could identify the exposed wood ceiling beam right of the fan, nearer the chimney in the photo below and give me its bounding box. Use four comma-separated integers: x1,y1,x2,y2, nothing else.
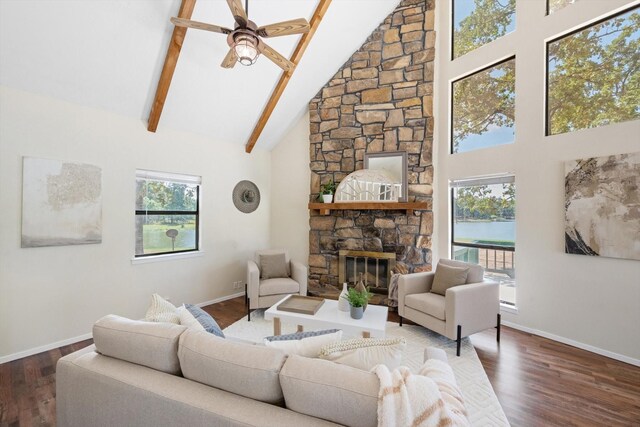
245,0,331,153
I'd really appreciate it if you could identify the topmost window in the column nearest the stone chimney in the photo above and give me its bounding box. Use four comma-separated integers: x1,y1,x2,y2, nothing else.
452,0,516,59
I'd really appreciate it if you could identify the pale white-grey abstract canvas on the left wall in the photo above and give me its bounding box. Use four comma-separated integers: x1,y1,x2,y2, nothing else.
22,157,102,248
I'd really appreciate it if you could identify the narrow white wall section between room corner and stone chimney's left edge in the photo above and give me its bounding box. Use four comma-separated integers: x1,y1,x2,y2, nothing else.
271,110,310,265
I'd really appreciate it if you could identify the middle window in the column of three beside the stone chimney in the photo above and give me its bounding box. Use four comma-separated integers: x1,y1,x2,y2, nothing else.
451,58,516,153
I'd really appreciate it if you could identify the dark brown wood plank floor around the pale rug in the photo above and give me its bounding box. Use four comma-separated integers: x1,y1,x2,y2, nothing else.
0,298,640,427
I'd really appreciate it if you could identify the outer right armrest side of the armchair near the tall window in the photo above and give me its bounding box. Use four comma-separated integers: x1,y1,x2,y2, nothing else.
445,280,500,339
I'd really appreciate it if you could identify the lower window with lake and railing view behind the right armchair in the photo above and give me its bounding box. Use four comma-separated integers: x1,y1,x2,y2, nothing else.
451,176,516,306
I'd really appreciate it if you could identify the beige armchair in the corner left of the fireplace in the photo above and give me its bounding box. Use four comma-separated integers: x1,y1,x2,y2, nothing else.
247,249,307,321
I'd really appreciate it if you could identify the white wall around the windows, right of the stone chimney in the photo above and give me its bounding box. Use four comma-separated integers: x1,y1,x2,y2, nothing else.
434,0,640,364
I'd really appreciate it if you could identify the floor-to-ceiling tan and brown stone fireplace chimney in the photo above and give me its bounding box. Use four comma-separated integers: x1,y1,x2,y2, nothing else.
309,0,435,304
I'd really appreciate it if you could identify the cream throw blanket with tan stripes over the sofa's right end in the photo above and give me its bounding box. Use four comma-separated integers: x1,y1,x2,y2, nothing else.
373,360,470,427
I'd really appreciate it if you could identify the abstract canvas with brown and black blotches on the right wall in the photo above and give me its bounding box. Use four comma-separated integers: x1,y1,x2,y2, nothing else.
565,152,640,260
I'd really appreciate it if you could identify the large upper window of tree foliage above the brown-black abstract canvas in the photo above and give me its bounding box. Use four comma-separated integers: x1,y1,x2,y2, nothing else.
547,7,640,135
